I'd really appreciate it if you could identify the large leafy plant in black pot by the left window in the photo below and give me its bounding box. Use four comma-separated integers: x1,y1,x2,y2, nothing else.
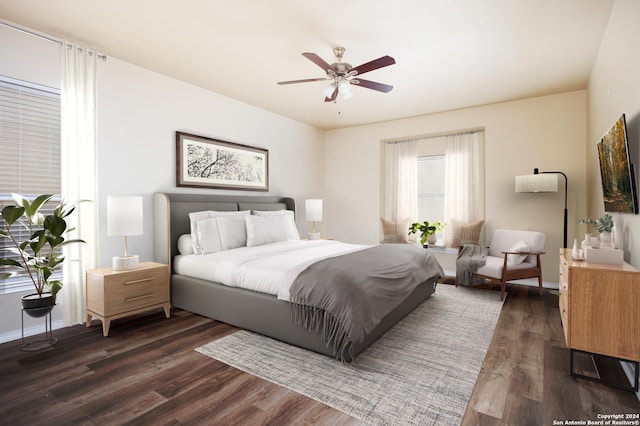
0,194,84,317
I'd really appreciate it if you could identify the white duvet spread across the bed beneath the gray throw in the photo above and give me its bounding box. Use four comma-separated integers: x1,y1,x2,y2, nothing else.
173,240,369,301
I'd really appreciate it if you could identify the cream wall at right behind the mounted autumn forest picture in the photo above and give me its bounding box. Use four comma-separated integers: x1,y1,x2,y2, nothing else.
586,0,640,269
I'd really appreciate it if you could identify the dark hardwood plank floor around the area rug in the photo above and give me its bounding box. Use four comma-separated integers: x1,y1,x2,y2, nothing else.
0,284,640,425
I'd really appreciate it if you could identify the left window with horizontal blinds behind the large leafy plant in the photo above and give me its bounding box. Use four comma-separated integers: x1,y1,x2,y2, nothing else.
0,76,61,293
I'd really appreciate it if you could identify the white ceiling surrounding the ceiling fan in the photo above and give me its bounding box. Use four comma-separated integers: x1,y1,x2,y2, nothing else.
0,0,614,129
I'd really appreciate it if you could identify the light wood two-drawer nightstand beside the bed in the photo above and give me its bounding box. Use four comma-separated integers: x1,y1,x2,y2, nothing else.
87,262,171,337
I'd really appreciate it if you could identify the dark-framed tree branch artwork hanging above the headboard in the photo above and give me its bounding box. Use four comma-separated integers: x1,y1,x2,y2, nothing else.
176,132,269,191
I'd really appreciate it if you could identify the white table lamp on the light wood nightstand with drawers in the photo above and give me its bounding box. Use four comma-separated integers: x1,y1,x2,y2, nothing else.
107,196,143,271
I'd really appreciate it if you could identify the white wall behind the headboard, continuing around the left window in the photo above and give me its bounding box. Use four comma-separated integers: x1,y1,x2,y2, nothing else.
0,27,324,341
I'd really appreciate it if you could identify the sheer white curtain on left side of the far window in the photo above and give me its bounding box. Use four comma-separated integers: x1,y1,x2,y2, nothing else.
384,140,418,223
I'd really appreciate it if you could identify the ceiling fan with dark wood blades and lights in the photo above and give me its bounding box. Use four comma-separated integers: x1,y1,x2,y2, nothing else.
278,47,396,102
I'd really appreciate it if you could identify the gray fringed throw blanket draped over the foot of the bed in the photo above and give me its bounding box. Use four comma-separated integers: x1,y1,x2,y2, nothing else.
289,244,444,361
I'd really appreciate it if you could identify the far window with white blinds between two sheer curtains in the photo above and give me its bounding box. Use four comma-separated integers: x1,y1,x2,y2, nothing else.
417,154,446,228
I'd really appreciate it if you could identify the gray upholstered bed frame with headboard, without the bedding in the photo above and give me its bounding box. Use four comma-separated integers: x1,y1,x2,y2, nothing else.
153,193,442,361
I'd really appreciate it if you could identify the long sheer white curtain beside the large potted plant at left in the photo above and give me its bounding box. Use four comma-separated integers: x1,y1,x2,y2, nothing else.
61,42,98,325
